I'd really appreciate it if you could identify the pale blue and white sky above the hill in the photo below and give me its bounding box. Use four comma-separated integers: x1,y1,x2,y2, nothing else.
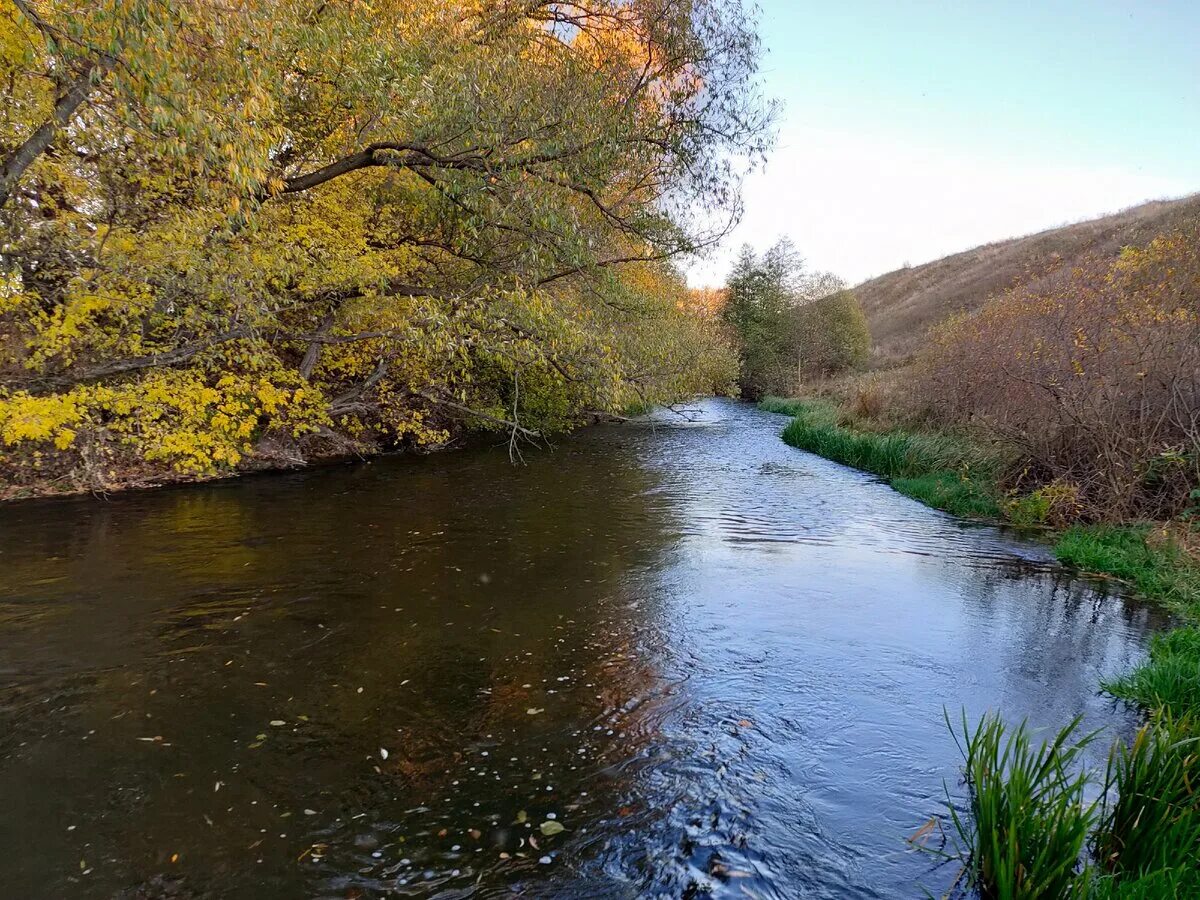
689,0,1200,286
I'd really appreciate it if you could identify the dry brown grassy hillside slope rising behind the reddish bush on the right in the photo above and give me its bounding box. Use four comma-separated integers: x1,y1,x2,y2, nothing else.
854,194,1200,365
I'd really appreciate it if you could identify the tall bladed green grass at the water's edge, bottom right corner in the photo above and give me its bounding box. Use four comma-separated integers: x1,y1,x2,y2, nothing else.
947,713,1200,900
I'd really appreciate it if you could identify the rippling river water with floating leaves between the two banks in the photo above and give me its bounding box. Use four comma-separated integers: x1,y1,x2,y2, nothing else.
0,401,1162,900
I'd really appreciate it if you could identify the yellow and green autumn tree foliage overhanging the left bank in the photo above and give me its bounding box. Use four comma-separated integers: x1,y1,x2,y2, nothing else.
0,0,770,494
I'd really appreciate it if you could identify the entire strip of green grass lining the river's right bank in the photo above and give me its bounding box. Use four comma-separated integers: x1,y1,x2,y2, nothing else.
760,398,1200,900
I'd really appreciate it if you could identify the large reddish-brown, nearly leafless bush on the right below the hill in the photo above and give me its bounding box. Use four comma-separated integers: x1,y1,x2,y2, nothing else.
911,223,1200,521
